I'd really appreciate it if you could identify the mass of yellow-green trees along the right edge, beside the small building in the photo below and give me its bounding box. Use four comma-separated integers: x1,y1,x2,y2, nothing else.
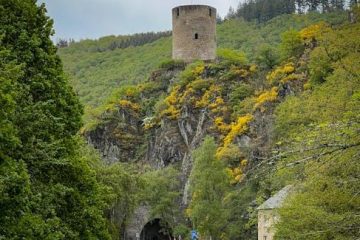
272,19,360,239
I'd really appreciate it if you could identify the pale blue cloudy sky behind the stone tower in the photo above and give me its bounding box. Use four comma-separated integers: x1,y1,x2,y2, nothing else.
39,0,239,40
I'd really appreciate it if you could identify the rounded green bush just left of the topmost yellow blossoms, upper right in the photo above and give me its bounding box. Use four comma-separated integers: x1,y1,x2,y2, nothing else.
279,30,304,59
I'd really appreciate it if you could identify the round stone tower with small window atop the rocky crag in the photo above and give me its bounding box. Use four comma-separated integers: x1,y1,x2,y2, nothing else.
172,5,216,62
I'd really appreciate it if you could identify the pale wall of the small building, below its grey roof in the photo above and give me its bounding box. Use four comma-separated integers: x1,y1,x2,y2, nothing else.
258,209,279,240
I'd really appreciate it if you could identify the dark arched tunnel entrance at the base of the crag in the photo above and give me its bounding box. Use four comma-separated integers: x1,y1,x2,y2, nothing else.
140,219,171,240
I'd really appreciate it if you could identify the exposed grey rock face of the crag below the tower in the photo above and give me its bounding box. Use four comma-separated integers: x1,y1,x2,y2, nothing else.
86,62,290,239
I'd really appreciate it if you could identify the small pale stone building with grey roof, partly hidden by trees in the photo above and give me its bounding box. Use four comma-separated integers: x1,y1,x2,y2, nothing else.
258,185,292,240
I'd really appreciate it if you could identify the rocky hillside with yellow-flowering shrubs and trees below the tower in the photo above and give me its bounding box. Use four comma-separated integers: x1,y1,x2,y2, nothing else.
74,9,360,240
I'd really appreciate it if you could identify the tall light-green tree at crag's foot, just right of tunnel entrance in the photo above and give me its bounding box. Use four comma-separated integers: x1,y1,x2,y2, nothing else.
187,137,230,239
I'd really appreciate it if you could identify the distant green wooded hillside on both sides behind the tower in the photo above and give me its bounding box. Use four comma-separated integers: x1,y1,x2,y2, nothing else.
58,13,346,113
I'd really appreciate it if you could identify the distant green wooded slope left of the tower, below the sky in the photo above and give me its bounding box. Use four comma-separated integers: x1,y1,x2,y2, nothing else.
59,38,171,107
